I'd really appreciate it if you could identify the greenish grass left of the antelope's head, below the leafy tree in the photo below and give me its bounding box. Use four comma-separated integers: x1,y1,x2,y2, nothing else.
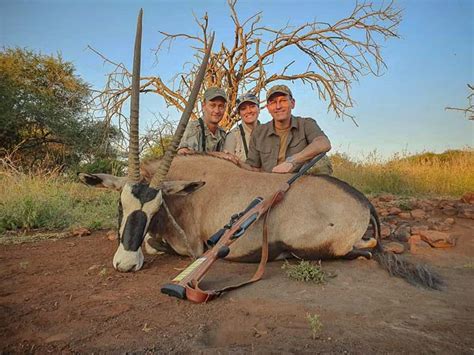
0,171,118,233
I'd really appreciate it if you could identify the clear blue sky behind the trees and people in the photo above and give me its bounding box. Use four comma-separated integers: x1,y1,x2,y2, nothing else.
0,0,474,159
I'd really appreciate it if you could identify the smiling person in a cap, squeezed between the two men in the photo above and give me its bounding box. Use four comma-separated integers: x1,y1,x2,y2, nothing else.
224,93,260,161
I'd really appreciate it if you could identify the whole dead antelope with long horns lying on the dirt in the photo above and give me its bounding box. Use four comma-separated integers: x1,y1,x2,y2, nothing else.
80,9,440,288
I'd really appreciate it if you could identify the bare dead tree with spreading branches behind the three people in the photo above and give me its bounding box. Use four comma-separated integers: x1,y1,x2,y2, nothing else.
92,0,401,134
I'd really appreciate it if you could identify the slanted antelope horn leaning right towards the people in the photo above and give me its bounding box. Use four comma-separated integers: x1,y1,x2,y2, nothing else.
150,33,214,189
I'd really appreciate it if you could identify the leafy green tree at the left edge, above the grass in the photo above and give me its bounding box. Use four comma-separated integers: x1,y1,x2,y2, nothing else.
0,48,118,167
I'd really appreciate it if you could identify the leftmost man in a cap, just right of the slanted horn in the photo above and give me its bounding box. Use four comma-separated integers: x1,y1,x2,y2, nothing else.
178,86,227,154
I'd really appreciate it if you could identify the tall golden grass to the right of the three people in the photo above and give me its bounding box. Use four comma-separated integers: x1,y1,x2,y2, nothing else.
331,149,474,197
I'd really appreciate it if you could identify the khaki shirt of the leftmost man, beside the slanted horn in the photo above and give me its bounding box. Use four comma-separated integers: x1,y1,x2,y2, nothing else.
178,120,225,153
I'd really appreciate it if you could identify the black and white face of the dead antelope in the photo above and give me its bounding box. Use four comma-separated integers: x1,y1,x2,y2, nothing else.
113,183,162,272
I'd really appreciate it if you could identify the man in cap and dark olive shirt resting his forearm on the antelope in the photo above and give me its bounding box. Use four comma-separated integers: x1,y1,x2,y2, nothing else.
246,85,332,175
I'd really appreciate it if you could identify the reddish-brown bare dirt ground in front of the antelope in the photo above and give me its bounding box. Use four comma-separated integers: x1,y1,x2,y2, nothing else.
0,203,474,354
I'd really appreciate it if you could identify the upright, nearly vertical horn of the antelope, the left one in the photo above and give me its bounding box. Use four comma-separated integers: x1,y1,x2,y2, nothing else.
128,9,143,182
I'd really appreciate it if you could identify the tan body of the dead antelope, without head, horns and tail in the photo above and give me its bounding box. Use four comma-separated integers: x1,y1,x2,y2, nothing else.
143,155,370,261
